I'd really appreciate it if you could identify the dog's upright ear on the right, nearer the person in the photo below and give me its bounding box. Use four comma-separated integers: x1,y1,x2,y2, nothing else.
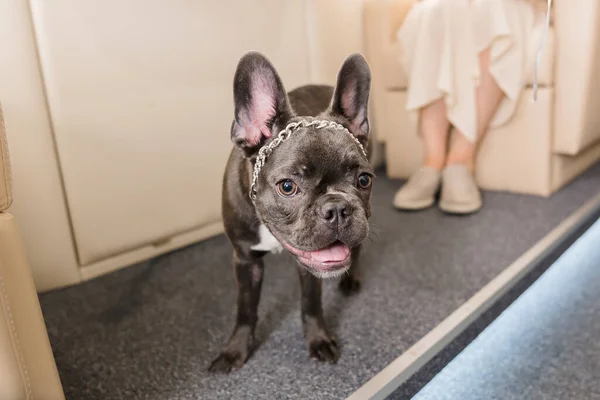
329,54,371,146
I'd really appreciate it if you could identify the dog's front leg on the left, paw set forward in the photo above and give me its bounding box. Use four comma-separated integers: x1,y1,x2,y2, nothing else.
209,253,264,372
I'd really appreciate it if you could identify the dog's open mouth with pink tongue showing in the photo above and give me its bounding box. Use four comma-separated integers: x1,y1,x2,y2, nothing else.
283,241,352,273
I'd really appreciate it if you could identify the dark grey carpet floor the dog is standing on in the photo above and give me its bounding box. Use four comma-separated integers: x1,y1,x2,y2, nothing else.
40,165,600,400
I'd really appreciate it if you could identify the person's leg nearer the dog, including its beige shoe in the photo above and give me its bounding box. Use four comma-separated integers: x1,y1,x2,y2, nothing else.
394,99,450,210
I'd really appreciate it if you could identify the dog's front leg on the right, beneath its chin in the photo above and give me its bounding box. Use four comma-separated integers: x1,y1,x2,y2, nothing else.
298,265,340,363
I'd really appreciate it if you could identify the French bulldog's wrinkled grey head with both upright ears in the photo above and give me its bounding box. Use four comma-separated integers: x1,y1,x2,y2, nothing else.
232,54,374,277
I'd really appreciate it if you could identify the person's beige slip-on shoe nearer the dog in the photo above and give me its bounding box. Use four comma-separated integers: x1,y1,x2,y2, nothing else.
394,166,442,211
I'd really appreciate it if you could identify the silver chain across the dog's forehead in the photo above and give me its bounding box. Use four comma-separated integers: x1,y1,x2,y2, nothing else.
250,119,367,203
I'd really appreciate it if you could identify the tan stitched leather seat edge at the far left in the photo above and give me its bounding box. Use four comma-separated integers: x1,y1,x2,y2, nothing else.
0,106,64,400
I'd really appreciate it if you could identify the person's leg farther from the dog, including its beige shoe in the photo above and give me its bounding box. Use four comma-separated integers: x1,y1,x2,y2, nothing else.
439,50,504,214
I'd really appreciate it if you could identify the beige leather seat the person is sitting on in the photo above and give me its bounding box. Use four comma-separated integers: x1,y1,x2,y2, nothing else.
363,0,600,196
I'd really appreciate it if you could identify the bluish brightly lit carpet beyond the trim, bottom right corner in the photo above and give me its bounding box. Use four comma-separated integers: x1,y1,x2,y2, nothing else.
413,216,600,400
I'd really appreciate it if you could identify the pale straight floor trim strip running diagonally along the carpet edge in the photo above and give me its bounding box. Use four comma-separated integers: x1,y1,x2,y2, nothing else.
347,194,600,400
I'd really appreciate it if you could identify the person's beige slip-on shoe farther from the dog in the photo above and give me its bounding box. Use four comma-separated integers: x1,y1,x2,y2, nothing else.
439,164,483,214
